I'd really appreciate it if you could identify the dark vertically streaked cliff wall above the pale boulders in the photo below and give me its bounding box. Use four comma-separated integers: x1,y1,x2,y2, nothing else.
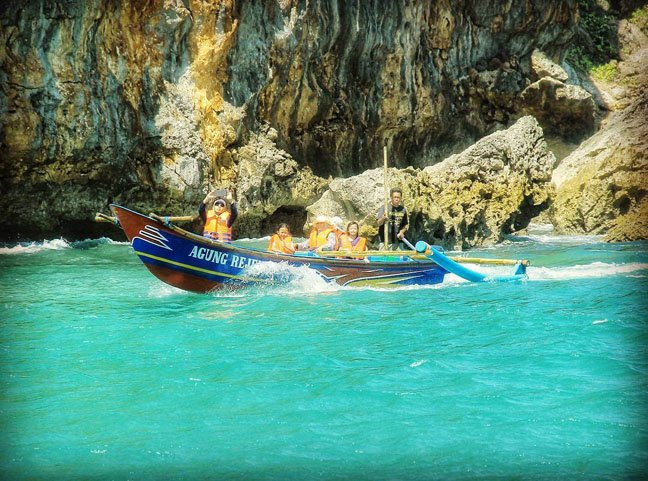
253,1,576,176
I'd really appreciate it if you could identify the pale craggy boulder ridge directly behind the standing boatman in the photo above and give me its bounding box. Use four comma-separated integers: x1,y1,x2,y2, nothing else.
308,117,555,249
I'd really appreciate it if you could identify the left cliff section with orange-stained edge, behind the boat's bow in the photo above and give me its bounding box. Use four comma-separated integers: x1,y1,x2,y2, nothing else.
0,1,225,238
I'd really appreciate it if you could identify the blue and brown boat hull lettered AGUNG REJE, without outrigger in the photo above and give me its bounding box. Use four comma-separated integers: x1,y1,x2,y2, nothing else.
111,205,448,293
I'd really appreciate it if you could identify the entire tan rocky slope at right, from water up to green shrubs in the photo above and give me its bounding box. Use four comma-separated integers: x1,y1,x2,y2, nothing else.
549,15,648,241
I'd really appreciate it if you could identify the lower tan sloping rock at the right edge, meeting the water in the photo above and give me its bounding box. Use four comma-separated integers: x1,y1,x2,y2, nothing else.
550,90,648,240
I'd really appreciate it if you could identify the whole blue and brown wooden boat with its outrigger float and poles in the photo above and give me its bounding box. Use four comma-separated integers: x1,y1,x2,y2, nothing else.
97,205,528,293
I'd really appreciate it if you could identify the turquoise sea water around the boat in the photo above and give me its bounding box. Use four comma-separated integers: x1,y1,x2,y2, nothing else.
0,227,648,480
